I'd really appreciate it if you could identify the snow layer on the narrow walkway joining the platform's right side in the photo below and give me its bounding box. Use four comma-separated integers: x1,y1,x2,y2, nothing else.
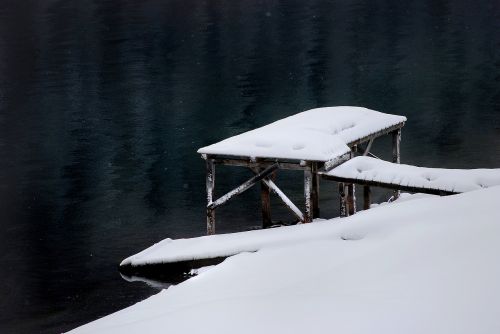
326,157,500,193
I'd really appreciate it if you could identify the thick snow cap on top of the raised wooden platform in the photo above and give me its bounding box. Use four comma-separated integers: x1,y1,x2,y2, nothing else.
198,107,406,161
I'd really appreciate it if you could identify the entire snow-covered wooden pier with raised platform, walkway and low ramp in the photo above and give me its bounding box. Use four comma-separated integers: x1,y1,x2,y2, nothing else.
120,107,500,281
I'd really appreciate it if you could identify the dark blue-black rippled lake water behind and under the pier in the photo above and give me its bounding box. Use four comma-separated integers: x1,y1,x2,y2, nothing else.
0,0,500,333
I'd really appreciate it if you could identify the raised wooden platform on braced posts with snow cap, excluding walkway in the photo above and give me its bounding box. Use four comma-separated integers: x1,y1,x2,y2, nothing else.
198,107,406,234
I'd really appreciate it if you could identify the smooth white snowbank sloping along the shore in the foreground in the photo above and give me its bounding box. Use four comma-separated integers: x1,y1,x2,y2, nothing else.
73,187,500,334
